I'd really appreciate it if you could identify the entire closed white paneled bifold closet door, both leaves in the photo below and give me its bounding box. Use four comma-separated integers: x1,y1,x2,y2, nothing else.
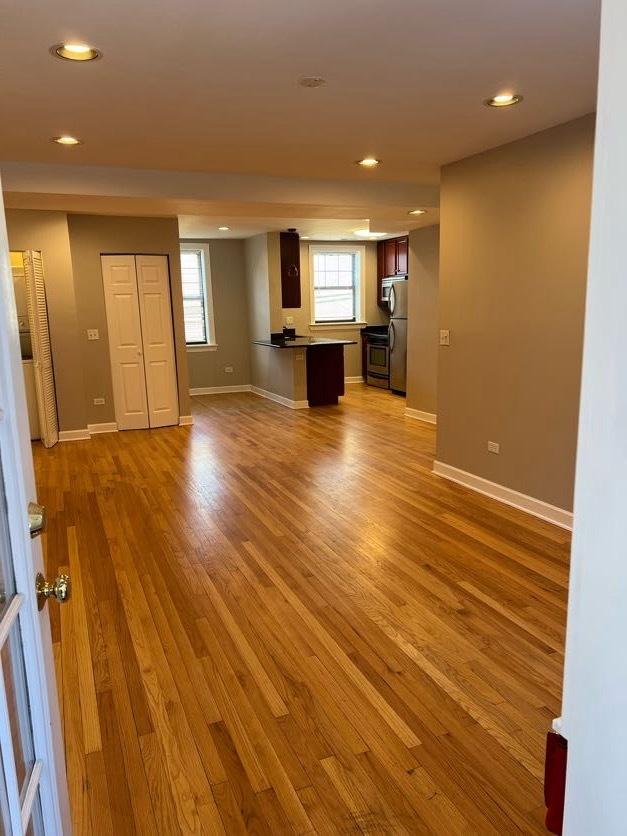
101,255,179,430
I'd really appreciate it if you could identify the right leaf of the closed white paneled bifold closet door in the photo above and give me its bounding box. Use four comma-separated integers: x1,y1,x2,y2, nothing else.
135,255,179,427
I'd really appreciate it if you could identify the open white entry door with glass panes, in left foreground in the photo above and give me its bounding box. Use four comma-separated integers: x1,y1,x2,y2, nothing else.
0,185,71,836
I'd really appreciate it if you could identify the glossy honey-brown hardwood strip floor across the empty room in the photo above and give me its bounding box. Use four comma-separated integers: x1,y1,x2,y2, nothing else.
35,386,569,836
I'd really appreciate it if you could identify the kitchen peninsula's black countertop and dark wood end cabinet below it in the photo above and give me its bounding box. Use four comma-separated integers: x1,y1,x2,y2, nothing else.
252,337,355,406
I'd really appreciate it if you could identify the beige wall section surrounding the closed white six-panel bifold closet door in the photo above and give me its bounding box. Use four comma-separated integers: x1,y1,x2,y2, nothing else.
68,215,190,424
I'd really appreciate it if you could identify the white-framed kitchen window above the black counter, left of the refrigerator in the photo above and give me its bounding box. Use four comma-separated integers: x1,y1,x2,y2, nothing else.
309,244,364,325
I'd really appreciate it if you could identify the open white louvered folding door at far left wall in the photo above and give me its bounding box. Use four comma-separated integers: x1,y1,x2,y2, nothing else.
24,250,59,447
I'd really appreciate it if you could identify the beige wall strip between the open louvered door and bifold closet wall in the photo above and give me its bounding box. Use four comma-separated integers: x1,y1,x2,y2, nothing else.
6,209,87,430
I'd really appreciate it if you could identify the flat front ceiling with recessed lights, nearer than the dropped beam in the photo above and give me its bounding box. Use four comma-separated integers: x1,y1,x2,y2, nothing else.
0,0,599,184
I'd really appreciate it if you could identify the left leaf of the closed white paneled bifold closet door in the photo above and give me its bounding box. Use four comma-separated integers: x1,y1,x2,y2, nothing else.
102,255,149,430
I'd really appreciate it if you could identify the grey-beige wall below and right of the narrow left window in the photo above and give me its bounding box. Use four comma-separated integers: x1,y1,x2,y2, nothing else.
186,239,250,389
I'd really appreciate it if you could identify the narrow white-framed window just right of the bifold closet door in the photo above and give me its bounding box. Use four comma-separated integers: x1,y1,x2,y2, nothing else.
181,243,215,349
